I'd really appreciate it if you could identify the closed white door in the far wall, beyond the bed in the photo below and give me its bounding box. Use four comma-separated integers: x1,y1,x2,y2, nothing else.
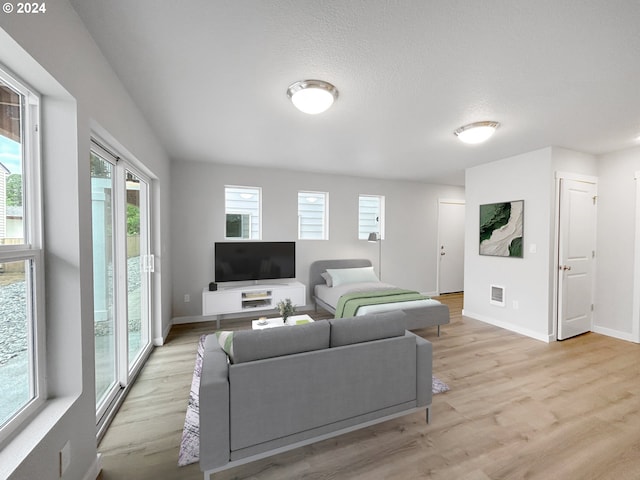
438,200,465,294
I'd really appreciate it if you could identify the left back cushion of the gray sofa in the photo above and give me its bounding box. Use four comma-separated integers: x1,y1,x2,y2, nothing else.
233,320,330,363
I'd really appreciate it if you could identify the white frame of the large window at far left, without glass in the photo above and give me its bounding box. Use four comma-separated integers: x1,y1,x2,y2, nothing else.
0,66,47,449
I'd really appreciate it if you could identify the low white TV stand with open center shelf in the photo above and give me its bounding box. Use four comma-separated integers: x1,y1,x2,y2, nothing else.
202,282,307,326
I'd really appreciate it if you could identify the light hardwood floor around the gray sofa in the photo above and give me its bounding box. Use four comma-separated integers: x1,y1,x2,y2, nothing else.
99,295,640,480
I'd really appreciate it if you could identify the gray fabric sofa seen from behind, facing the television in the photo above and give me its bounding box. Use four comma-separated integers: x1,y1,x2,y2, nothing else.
200,312,432,479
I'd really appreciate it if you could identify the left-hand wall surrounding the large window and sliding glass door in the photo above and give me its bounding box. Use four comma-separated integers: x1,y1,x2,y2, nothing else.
0,0,171,480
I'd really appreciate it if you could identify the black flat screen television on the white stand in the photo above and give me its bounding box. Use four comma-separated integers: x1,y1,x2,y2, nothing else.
214,242,296,282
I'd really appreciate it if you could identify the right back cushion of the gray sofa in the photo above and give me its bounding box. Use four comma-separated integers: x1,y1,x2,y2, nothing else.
330,310,406,347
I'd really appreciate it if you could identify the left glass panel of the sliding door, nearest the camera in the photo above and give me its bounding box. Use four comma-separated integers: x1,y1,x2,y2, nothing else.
91,152,118,411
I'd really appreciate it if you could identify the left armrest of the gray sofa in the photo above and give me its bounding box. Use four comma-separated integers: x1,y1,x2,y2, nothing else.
199,335,231,471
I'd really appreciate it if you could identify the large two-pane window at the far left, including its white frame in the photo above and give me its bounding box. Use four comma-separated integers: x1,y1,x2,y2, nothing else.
0,70,46,440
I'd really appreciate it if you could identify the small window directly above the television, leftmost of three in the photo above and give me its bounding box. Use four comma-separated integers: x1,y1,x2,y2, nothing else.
224,186,262,240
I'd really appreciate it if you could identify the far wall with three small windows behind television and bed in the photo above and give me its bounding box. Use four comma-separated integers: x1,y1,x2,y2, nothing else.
171,162,464,317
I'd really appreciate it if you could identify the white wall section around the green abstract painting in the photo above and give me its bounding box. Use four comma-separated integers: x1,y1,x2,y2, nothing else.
464,148,553,341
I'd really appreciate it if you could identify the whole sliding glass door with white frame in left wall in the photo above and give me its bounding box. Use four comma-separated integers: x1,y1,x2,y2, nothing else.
91,144,153,423
